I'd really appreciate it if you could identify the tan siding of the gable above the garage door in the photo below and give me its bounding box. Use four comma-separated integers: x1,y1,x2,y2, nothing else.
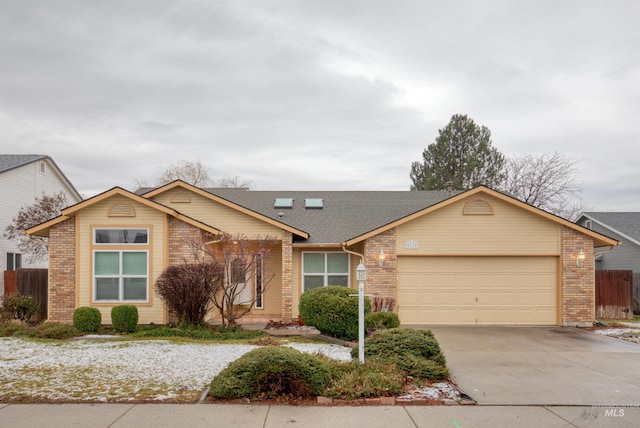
396,196,560,255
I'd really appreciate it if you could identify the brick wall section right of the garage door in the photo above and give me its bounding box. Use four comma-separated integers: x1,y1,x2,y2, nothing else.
561,226,595,326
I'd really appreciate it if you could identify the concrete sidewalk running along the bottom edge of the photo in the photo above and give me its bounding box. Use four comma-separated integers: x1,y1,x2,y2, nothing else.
0,403,640,428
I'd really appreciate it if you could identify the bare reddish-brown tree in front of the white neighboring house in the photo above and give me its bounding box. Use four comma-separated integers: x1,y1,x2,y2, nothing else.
4,192,69,263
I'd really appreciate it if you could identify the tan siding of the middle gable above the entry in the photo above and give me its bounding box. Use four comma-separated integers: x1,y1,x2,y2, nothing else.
154,189,282,239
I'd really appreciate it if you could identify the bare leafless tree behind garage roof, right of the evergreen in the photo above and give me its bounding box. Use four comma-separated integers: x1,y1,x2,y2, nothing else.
500,152,586,220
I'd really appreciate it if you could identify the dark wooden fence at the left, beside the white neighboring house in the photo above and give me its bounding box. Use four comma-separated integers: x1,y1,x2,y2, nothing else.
4,269,49,320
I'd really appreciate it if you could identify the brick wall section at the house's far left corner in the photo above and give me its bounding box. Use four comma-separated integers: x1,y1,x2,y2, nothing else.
49,217,76,323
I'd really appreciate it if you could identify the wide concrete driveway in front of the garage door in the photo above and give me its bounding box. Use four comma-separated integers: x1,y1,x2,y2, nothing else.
424,327,640,407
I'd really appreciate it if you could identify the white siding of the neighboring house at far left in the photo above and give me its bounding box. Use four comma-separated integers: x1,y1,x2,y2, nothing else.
0,159,79,295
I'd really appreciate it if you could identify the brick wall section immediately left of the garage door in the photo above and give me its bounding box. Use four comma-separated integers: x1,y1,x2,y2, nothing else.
356,228,398,298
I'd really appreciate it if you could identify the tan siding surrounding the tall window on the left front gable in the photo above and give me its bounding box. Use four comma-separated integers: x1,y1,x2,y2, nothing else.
77,196,166,324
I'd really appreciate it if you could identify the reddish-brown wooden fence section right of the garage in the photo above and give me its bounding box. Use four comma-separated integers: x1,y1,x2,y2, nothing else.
596,270,633,319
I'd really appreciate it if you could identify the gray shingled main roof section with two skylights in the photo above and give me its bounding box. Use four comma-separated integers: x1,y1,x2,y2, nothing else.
204,188,452,244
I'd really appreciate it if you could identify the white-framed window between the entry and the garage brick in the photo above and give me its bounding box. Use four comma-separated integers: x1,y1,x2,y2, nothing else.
302,253,349,292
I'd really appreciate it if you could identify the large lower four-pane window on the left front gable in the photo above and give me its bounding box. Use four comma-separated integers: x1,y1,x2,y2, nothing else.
93,251,148,302
